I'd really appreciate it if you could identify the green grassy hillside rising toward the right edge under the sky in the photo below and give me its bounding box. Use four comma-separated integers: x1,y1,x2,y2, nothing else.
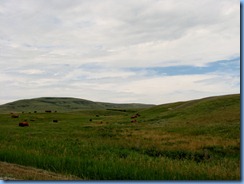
141,94,241,120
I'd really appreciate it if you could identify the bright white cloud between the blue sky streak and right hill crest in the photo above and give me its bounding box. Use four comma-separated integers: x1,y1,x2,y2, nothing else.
110,74,240,104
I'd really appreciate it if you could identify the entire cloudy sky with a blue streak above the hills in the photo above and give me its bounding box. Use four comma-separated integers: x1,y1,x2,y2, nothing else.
0,0,240,104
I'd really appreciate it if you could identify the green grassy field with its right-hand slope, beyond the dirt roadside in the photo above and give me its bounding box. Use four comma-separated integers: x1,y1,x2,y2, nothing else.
0,95,240,180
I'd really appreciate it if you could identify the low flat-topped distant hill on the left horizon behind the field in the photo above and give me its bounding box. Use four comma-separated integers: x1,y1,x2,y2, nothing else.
0,97,154,113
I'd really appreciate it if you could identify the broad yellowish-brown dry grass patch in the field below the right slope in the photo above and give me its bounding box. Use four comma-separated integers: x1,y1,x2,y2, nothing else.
120,130,238,151
